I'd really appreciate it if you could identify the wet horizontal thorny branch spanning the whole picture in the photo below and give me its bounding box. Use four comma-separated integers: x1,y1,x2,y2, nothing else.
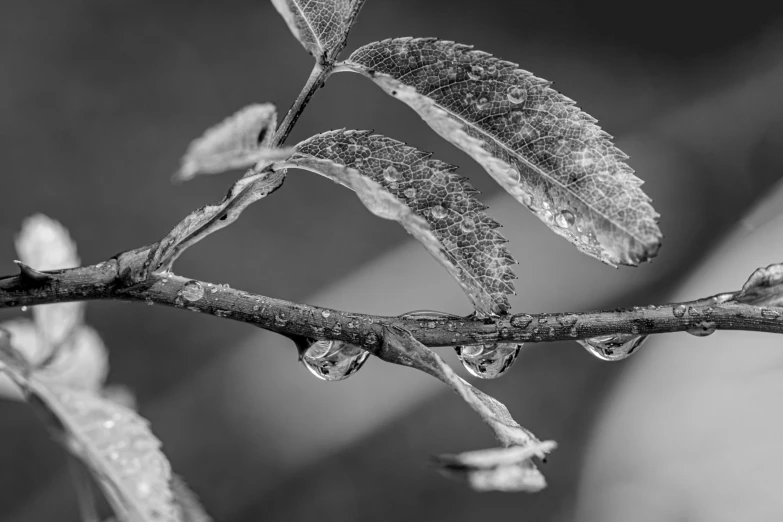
0,247,783,352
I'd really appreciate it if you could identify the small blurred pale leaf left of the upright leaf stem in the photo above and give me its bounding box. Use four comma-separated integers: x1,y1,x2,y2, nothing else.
174,103,284,181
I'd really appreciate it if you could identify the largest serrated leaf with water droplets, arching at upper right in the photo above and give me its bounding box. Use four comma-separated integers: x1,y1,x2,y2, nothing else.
338,38,661,265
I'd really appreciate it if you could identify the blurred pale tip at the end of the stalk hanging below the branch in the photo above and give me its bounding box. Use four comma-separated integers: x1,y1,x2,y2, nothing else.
434,441,556,493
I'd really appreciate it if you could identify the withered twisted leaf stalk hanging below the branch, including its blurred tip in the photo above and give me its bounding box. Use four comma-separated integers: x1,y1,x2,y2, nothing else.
376,327,555,491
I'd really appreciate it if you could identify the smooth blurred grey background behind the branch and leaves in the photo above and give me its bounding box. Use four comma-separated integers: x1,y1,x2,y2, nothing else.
0,0,783,522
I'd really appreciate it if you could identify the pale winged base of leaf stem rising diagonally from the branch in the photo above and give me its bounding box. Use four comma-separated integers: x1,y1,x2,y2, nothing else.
139,169,285,280
